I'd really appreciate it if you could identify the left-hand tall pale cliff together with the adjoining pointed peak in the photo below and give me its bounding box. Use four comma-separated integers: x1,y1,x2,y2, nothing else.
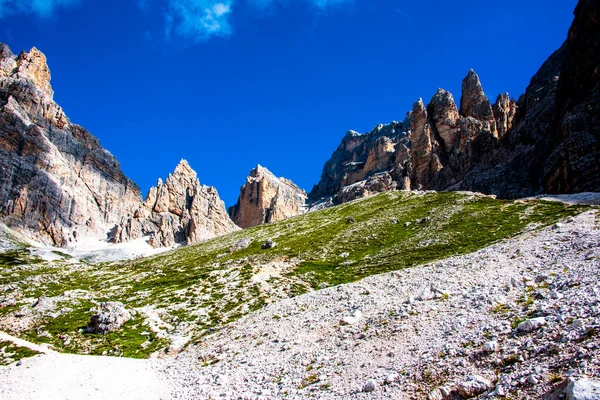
0,44,237,246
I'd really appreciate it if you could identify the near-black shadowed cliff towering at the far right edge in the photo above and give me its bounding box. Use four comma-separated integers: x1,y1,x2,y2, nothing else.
542,0,600,193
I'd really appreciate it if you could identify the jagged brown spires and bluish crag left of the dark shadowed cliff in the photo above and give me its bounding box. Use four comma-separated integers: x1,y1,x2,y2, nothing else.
310,71,517,203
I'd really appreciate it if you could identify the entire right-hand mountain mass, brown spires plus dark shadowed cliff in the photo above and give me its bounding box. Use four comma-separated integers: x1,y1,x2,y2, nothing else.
309,0,600,203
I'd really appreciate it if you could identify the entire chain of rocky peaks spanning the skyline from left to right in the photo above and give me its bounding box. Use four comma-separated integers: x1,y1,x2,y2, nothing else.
0,0,600,247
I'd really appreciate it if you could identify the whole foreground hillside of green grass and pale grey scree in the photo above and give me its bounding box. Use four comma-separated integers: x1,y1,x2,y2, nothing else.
0,192,600,399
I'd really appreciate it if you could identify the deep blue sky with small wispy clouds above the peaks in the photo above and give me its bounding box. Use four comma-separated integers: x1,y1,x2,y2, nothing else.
0,0,577,206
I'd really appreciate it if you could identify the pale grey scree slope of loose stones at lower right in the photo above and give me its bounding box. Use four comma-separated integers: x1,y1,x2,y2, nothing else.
163,213,600,400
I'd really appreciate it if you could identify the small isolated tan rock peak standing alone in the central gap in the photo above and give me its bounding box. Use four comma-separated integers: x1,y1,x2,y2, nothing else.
229,165,307,228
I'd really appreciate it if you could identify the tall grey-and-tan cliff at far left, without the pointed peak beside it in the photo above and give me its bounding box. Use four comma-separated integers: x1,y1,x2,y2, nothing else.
0,44,140,246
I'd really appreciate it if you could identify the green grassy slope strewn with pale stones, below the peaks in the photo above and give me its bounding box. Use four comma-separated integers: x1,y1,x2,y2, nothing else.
0,192,589,357
